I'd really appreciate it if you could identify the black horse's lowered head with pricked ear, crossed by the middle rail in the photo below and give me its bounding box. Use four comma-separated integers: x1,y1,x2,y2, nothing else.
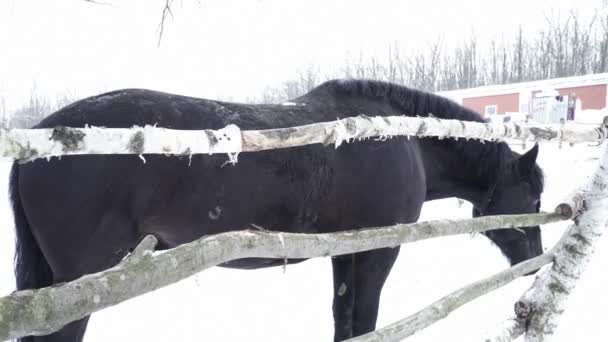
473,145,543,265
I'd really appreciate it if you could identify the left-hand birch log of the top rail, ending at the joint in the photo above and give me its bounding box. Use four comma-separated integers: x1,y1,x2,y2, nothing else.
0,125,241,161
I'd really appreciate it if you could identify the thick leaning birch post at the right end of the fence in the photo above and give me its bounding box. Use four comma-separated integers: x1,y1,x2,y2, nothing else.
516,142,608,342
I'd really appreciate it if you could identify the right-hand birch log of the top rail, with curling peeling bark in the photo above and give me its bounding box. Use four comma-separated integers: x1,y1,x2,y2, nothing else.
242,115,608,151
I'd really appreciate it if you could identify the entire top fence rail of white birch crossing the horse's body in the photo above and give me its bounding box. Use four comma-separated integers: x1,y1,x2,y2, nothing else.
0,115,608,162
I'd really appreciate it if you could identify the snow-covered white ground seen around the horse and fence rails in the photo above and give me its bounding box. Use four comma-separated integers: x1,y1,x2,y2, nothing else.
0,140,608,342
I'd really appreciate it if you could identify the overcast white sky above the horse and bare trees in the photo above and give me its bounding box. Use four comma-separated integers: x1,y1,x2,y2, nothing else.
0,0,600,110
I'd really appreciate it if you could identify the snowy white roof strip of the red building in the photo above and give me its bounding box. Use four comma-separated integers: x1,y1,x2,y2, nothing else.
437,73,608,99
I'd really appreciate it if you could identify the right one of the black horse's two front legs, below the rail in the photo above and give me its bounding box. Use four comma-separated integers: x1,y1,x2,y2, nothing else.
353,247,399,337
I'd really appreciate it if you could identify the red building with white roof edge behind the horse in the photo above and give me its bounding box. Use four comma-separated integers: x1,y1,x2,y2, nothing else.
438,73,608,115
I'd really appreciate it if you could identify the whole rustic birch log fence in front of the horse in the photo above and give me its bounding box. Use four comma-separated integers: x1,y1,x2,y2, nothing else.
0,115,608,341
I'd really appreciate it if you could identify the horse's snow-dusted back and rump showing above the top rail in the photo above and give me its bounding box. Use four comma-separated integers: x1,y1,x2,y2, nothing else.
36,89,328,129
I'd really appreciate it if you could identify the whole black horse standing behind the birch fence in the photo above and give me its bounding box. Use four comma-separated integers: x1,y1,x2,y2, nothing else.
10,80,543,342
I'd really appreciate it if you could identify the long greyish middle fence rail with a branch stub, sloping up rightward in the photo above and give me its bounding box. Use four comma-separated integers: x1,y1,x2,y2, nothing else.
0,213,563,341
